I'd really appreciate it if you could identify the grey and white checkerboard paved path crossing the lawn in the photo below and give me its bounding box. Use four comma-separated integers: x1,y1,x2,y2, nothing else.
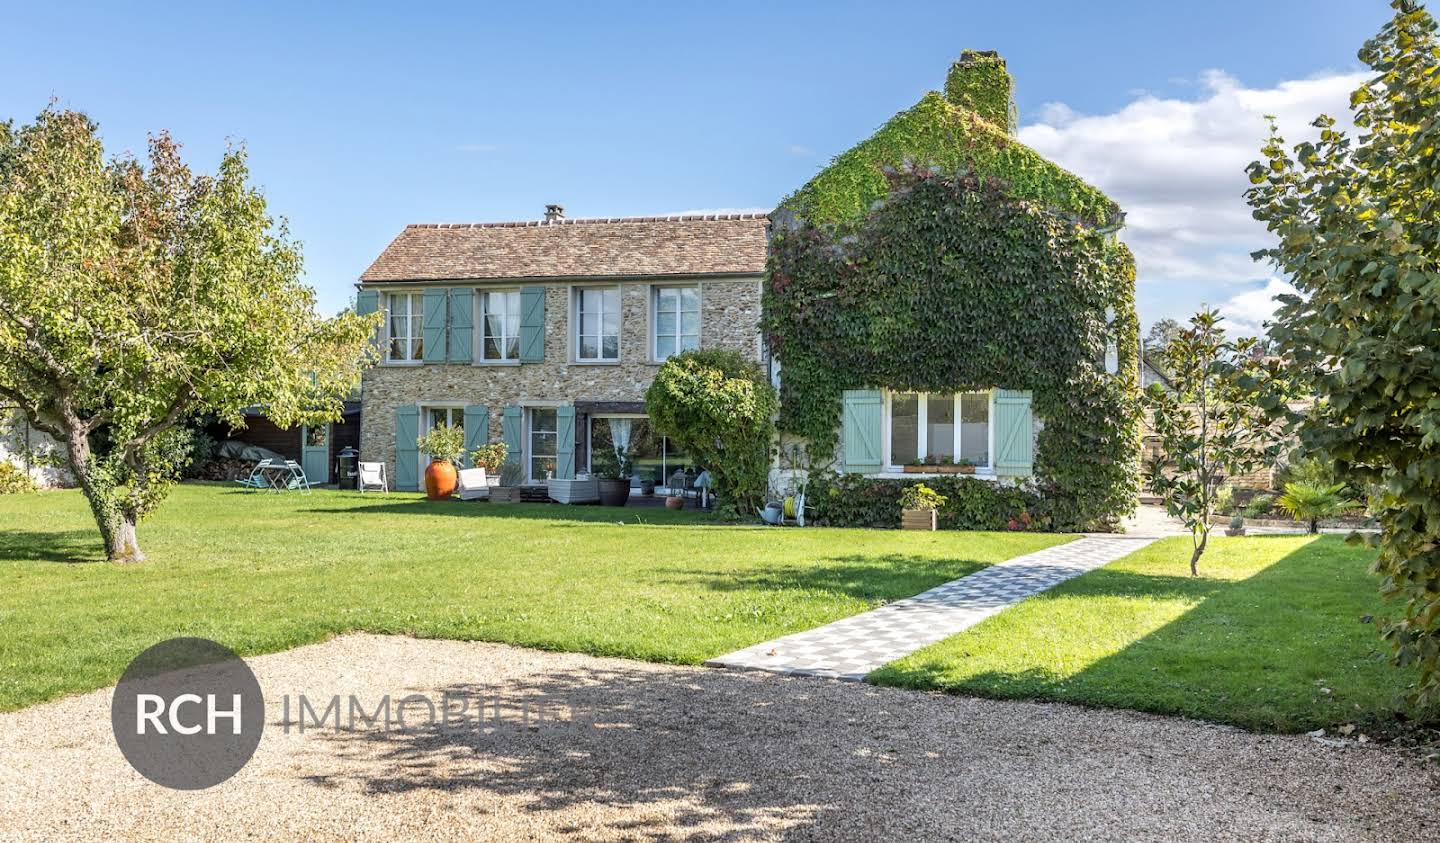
706,535,1155,682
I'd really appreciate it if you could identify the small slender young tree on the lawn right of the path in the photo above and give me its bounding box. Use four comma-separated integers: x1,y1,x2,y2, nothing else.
1145,310,1279,576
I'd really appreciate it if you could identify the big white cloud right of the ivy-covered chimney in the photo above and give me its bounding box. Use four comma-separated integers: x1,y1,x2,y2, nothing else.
1020,71,1365,318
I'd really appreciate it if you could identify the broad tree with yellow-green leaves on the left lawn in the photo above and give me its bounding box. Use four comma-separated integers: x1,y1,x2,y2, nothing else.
0,108,376,561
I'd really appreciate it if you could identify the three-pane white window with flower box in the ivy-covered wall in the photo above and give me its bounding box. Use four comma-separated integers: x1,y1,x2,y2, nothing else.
886,392,994,470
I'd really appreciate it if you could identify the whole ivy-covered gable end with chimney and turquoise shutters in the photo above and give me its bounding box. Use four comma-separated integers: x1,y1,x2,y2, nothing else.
762,55,1139,529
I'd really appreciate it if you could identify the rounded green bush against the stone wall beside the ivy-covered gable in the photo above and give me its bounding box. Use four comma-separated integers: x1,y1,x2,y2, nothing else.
645,349,779,513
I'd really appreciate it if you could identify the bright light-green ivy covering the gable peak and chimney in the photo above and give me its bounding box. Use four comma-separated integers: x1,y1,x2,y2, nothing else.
780,50,1120,225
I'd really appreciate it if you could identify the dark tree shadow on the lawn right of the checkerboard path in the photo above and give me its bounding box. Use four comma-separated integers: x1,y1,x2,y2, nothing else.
870,539,1440,733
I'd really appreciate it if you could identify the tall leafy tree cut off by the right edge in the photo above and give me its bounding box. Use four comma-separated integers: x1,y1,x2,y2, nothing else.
1247,0,1440,705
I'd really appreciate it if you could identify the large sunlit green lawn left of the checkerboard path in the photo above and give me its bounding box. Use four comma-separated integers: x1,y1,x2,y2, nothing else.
0,484,1066,710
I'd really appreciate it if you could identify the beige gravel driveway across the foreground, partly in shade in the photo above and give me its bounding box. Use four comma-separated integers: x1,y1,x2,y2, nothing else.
0,635,1440,840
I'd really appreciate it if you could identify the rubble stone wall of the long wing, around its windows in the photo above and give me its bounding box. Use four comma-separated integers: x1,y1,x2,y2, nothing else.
360,277,760,478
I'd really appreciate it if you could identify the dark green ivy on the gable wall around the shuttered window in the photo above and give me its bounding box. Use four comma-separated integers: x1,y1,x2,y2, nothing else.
763,166,1139,529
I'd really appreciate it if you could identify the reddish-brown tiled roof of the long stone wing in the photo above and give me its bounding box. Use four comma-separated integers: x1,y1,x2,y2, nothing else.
360,213,769,281
